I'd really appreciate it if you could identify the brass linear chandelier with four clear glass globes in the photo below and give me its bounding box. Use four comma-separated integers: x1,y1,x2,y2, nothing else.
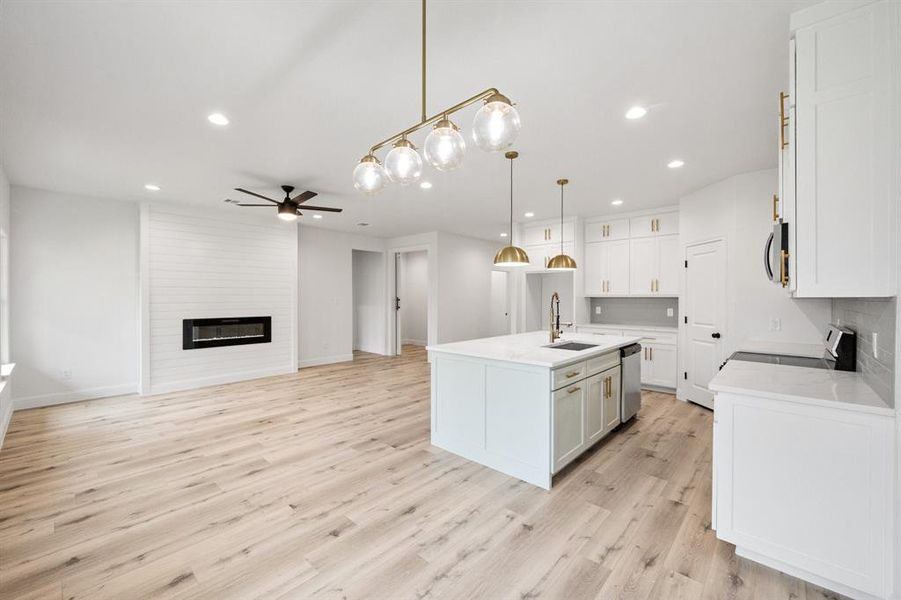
353,0,521,194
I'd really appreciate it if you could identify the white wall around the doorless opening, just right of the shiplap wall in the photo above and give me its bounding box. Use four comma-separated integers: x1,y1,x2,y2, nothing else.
297,225,387,367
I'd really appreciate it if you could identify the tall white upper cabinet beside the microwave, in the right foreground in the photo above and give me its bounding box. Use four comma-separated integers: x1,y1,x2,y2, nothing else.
783,0,901,297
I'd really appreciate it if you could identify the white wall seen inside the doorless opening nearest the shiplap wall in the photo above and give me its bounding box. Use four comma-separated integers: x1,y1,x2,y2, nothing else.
351,250,385,354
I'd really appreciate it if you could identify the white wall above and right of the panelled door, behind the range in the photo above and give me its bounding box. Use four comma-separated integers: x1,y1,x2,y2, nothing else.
679,169,832,397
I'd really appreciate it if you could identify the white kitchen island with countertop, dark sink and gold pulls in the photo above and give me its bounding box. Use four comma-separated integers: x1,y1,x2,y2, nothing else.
426,331,639,490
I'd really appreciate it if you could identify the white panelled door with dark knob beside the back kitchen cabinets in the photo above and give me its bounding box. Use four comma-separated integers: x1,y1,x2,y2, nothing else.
682,240,726,408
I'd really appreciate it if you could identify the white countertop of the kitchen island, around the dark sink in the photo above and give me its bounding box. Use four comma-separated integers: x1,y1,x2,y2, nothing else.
426,331,640,369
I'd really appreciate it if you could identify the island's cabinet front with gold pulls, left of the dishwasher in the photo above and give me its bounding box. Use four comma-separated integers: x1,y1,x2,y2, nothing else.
551,350,620,473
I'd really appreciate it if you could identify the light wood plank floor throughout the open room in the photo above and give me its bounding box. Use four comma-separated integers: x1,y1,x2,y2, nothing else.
0,347,834,600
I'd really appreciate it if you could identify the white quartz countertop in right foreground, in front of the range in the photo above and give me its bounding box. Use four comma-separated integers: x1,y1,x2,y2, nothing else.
708,360,895,417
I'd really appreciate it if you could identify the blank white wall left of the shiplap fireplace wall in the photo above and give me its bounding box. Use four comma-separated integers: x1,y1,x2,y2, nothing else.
10,187,139,408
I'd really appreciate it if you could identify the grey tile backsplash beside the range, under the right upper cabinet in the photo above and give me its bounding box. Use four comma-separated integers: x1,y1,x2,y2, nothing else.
832,298,897,406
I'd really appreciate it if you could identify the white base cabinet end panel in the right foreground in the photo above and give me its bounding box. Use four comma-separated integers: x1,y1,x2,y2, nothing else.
712,393,897,598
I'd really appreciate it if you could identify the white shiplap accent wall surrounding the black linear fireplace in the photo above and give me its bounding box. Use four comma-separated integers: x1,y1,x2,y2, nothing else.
140,203,297,394
